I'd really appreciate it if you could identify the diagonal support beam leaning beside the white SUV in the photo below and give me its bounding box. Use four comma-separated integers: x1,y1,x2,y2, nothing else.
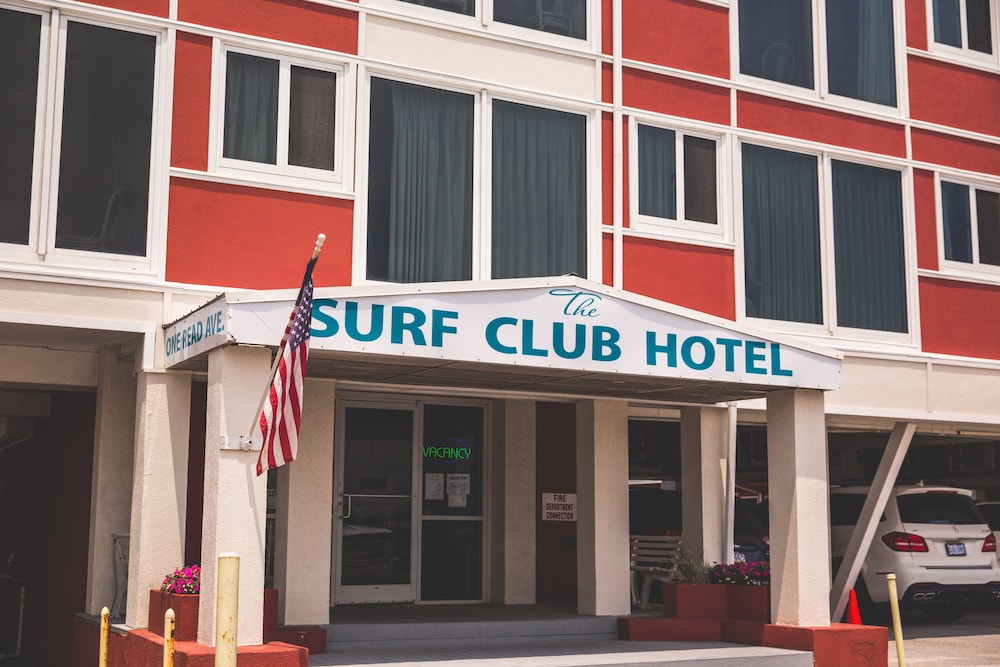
830,422,916,621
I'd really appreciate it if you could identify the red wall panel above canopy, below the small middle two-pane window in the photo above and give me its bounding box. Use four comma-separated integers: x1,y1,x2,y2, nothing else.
623,238,736,320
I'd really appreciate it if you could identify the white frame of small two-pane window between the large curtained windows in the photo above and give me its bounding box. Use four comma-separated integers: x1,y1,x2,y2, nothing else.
628,115,733,247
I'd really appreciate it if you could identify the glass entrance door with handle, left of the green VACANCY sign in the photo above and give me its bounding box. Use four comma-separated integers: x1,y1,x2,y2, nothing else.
333,406,416,604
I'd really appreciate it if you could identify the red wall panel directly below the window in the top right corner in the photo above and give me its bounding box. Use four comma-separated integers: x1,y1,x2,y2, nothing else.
907,56,1000,136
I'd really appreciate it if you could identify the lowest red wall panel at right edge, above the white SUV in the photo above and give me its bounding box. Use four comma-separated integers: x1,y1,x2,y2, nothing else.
920,278,1000,359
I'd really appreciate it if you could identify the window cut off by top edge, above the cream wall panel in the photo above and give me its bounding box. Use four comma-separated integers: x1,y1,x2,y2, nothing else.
390,0,587,39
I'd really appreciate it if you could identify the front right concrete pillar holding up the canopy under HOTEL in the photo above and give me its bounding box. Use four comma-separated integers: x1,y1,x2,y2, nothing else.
767,389,830,626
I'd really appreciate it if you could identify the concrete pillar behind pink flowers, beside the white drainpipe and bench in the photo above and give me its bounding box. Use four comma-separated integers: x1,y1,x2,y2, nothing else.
681,407,729,563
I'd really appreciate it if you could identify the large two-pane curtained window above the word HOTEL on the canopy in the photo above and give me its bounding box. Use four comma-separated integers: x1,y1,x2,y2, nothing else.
743,145,907,333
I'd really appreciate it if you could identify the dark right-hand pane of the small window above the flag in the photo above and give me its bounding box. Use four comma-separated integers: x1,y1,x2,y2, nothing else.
288,67,337,171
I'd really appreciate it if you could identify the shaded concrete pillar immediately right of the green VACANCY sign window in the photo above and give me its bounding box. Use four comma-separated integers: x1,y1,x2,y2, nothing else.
490,400,537,604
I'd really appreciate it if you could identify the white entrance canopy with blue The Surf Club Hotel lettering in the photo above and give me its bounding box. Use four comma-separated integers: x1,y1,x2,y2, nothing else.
163,276,841,403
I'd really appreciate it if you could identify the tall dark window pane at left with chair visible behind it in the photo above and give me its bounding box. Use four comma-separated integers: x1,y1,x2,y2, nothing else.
56,23,156,256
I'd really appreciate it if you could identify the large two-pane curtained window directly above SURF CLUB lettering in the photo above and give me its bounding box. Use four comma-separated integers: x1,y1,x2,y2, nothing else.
366,78,587,282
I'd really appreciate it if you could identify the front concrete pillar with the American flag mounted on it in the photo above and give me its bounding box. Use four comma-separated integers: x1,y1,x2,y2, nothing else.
198,345,272,646
